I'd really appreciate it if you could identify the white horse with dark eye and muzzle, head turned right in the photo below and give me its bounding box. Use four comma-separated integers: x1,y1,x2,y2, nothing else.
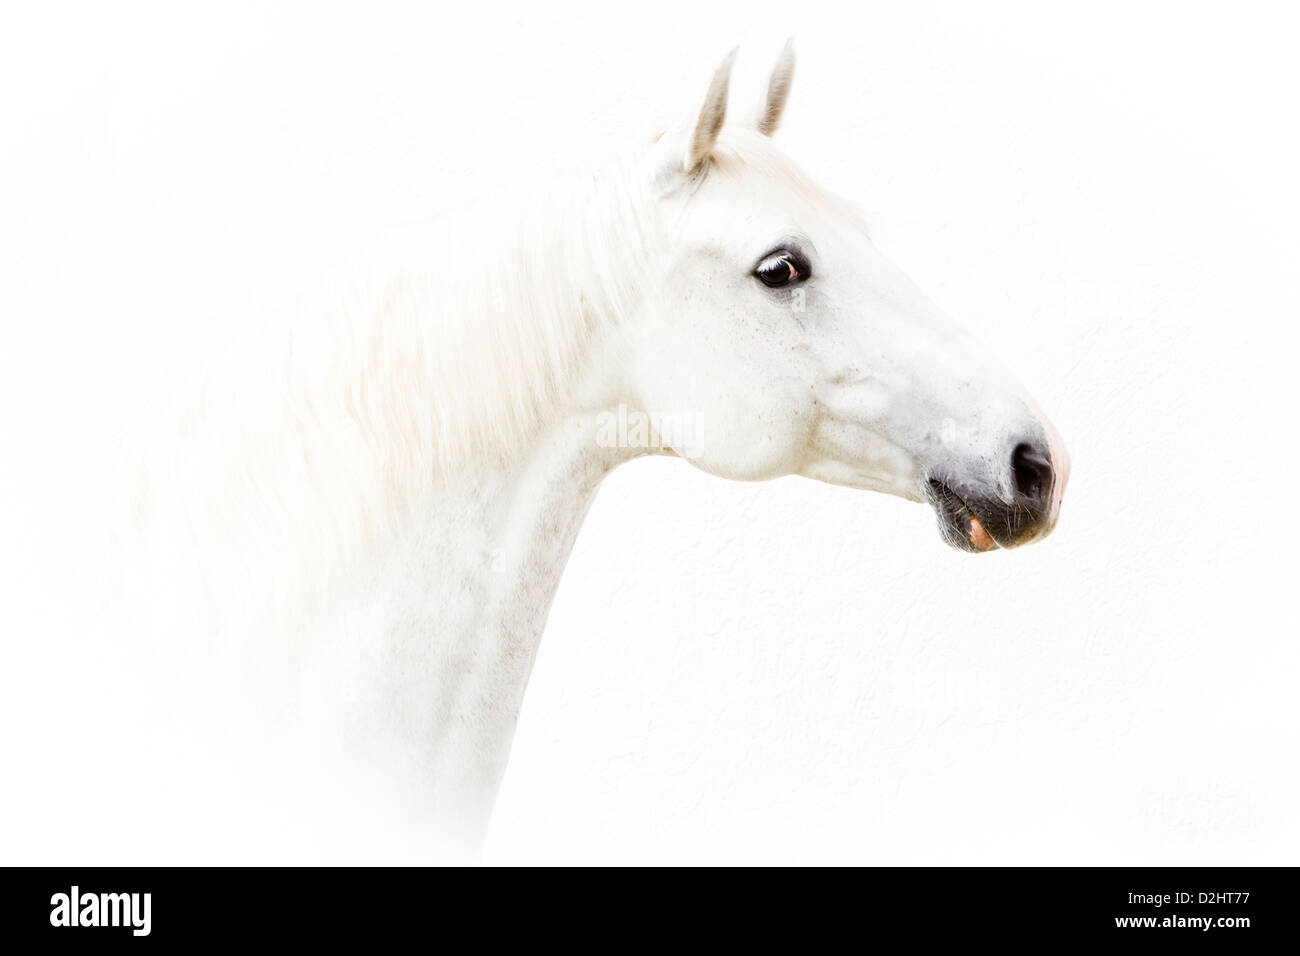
106,46,1069,858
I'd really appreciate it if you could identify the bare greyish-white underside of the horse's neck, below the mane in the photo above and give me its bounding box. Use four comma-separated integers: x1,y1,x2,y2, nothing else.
297,358,644,839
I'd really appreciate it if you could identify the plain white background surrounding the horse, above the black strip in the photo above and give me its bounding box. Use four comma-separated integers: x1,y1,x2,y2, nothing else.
0,1,1300,864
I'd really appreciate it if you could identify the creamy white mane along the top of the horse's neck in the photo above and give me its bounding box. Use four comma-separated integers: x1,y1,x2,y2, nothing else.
118,147,658,629
